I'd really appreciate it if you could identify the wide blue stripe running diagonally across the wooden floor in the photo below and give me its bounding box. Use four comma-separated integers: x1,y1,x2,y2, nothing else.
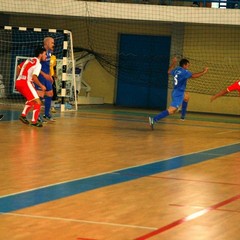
0,143,240,213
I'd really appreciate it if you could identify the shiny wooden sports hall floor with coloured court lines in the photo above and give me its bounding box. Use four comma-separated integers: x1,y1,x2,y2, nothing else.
0,106,240,240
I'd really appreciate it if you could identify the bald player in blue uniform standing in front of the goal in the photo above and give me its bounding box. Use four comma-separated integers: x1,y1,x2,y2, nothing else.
36,37,55,121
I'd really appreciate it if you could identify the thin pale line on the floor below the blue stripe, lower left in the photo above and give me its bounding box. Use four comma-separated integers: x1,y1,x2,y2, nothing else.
0,212,158,230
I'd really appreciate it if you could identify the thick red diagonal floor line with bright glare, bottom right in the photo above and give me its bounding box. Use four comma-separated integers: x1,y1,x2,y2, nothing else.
134,194,240,240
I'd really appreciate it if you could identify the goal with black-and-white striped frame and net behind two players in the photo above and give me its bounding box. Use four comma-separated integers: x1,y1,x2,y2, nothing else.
0,26,77,111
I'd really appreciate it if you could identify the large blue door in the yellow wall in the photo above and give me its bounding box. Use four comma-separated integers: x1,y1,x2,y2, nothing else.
116,34,171,109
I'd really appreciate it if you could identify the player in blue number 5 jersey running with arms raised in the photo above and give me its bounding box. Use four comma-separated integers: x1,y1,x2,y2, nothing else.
149,57,208,130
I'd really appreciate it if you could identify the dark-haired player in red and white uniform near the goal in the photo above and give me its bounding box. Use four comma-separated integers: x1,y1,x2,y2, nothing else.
16,46,47,127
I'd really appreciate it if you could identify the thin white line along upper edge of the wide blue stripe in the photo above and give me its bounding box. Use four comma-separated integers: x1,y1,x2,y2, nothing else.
0,142,239,199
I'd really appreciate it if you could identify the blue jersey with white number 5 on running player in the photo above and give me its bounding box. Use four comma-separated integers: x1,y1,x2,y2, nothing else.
170,67,192,92
